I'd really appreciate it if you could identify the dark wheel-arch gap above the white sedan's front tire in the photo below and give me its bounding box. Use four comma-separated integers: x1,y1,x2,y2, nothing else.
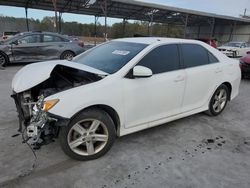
71,104,121,136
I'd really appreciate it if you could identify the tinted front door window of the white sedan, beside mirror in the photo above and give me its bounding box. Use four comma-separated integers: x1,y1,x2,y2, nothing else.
137,44,180,74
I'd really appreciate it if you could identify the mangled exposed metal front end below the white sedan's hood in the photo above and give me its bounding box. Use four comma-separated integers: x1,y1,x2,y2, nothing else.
12,93,61,149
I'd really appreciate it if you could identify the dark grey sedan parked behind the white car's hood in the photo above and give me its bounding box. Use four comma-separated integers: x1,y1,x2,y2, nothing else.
0,32,85,66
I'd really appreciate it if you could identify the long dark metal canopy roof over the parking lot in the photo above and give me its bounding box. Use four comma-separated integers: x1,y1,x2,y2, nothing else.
0,0,250,25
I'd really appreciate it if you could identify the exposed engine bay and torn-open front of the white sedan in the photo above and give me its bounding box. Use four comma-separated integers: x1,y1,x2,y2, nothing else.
12,65,104,149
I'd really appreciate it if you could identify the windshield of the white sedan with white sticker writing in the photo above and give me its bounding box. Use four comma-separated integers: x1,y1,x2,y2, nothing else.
73,41,147,74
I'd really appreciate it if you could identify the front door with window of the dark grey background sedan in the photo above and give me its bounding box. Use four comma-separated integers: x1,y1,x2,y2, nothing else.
11,34,41,62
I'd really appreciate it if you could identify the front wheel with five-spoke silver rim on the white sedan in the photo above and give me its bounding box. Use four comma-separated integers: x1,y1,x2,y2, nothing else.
59,109,116,161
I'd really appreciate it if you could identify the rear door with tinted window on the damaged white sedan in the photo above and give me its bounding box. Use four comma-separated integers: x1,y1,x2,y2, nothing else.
180,44,220,112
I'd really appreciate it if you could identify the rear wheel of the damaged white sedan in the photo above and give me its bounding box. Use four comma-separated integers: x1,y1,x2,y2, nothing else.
207,84,229,116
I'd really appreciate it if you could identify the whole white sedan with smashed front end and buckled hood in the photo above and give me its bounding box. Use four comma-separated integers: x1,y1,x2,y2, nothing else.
12,38,241,160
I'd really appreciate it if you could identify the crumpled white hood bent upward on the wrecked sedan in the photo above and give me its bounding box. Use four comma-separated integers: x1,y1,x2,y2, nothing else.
12,60,108,93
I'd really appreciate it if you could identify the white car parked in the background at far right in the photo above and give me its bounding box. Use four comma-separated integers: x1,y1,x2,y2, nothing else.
218,42,250,57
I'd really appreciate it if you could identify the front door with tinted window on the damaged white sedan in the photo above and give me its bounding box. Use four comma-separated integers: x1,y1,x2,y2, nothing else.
123,44,186,128
